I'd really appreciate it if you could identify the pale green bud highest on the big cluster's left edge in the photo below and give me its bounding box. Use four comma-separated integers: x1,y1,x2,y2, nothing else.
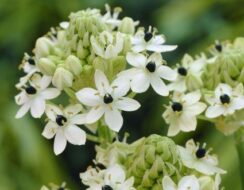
34,37,53,59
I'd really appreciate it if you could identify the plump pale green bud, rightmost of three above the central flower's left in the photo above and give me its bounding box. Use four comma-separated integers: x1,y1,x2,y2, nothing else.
65,55,82,76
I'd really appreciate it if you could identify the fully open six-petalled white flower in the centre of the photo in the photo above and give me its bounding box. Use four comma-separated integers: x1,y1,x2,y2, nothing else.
76,70,140,132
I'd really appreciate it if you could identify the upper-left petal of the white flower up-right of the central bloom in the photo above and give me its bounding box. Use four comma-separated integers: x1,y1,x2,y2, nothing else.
126,52,147,68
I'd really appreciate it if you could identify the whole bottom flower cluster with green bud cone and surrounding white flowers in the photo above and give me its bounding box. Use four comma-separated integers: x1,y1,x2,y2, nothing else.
80,135,225,190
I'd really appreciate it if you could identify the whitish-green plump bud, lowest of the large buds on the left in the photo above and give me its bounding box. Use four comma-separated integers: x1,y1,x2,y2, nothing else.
52,67,73,89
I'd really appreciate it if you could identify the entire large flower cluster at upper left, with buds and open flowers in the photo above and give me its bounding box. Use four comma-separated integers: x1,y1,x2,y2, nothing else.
16,5,177,155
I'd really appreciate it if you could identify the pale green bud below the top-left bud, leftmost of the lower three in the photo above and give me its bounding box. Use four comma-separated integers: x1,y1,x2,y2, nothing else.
37,57,56,76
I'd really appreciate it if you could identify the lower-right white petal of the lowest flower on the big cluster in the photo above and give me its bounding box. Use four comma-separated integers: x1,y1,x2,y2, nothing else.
64,125,86,145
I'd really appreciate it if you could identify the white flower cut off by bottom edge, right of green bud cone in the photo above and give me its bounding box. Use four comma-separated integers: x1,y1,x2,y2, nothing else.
162,175,200,190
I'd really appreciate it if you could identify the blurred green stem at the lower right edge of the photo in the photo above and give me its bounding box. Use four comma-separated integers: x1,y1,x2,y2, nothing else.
235,127,244,189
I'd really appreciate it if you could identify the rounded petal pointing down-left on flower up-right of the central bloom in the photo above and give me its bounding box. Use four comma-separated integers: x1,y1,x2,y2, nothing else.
130,72,150,93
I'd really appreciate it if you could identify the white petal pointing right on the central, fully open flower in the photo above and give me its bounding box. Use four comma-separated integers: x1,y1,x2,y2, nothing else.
115,97,141,111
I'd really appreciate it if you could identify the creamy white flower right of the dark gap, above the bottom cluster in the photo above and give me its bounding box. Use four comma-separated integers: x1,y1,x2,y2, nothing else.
163,91,206,136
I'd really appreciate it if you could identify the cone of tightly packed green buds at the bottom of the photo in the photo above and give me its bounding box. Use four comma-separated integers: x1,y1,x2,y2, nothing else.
125,135,181,190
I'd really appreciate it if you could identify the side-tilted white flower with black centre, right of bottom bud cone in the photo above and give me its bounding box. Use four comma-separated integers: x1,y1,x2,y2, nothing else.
178,139,226,175
